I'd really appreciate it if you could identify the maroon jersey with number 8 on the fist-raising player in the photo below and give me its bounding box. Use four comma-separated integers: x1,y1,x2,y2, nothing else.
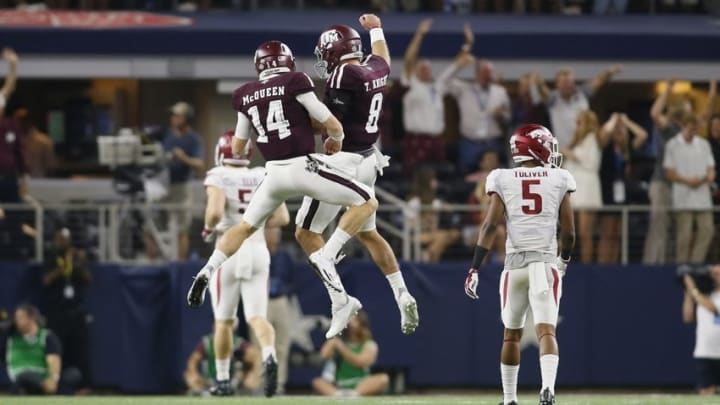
325,55,390,152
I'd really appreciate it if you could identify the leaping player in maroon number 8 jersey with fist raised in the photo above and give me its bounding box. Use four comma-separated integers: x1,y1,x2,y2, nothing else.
295,14,419,334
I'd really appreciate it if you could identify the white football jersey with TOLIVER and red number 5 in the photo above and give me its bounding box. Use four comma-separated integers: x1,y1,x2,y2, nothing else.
485,167,577,255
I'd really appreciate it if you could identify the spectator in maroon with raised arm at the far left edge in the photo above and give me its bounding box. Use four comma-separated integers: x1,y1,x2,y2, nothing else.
0,48,22,203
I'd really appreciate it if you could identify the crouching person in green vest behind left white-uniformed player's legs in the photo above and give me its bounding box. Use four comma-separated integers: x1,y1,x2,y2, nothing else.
183,326,262,395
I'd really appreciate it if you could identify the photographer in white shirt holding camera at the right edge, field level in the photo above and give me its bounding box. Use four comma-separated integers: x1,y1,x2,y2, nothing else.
682,265,720,395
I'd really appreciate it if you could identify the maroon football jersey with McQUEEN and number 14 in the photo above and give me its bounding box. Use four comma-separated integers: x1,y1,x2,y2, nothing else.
233,72,315,160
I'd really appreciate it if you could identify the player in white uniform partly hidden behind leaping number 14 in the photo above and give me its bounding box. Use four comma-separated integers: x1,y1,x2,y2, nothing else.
203,131,290,397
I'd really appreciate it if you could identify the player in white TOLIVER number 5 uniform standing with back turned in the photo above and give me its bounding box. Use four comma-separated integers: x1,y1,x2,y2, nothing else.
465,125,576,405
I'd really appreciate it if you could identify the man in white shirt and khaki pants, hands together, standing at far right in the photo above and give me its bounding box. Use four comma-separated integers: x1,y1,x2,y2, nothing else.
663,114,715,263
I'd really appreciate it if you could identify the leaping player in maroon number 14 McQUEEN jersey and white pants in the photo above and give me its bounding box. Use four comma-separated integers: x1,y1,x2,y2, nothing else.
188,41,377,354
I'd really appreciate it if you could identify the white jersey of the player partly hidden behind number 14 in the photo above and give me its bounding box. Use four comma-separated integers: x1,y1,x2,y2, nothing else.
203,166,265,240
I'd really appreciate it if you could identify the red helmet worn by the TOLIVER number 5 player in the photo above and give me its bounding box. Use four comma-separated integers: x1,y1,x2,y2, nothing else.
510,124,562,167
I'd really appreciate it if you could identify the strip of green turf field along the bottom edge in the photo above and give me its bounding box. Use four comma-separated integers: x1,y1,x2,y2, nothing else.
0,394,720,405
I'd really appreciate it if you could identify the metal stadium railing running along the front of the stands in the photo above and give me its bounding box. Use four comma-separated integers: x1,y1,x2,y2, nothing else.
0,188,720,265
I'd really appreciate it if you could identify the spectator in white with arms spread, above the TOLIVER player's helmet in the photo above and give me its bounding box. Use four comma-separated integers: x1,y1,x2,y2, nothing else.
533,65,622,148
